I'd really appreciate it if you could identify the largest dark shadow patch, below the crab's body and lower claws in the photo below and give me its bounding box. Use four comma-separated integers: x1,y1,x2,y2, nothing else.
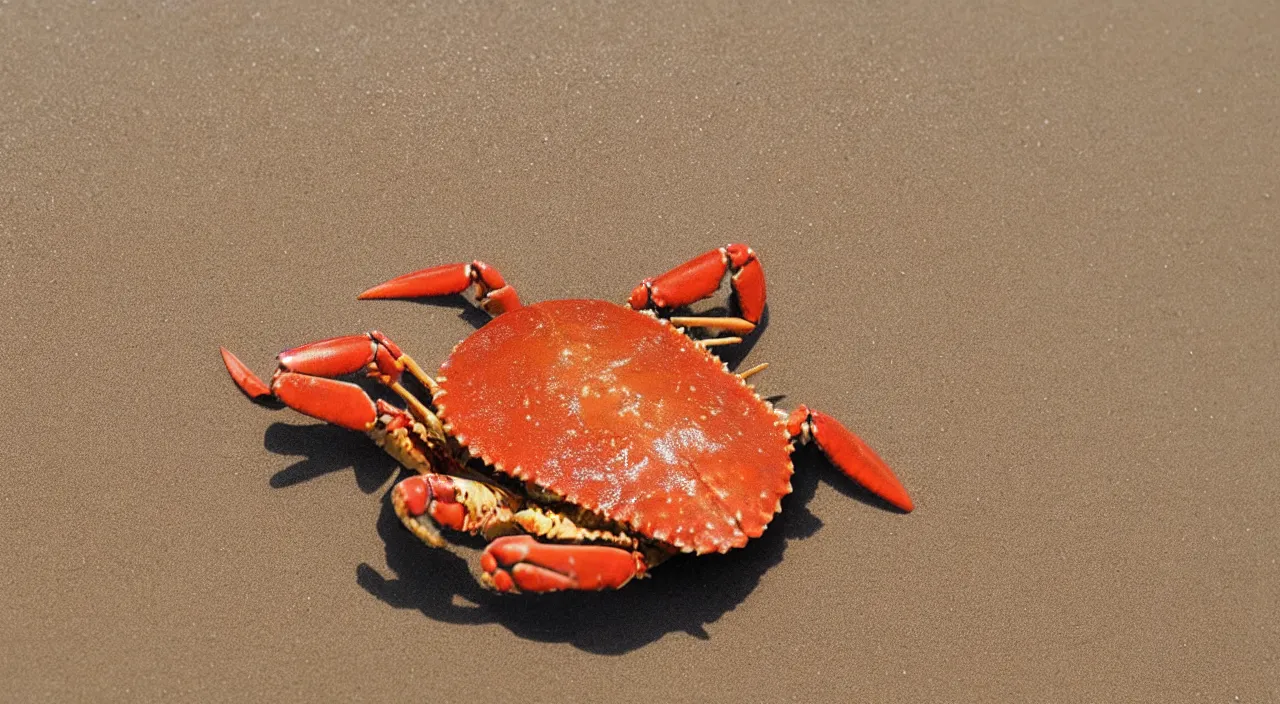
356,453,822,654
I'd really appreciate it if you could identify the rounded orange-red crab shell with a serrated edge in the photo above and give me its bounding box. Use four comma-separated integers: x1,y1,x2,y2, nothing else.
434,300,792,553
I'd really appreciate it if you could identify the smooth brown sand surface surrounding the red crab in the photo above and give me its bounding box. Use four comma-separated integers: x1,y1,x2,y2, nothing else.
0,0,1280,703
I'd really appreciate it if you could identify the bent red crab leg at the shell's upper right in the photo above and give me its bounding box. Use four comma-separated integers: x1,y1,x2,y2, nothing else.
627,244,764,324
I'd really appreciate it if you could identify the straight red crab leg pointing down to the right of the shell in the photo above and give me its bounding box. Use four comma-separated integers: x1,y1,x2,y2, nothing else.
787,406,915,511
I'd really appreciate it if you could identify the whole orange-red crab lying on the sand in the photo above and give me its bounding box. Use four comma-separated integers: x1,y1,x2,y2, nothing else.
221,244,913,593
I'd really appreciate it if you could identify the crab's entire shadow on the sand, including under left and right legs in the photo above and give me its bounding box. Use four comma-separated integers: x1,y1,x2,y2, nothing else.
264,422,887,654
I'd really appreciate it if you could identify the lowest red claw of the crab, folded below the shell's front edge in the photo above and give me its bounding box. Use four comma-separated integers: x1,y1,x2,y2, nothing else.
480,535,649,591
